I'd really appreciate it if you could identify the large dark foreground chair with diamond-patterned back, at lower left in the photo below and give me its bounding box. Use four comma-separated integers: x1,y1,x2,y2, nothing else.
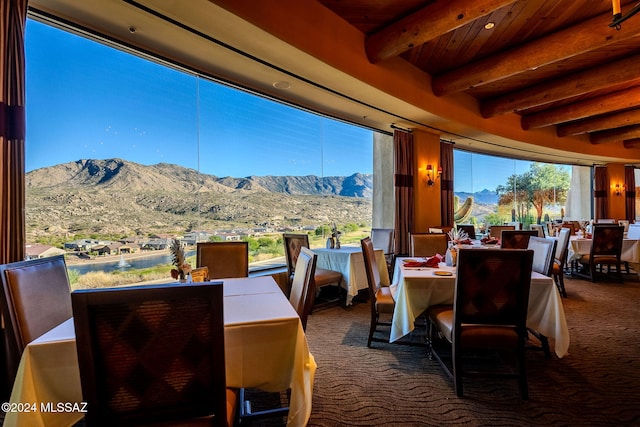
71,282,238,427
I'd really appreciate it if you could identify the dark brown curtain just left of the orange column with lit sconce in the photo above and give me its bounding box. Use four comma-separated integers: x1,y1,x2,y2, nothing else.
393,130,414,255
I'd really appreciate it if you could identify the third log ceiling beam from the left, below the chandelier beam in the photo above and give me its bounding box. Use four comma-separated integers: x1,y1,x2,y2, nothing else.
480,55,640,118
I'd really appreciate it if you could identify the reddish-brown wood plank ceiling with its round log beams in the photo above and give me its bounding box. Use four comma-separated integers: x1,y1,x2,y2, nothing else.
318,0,640,148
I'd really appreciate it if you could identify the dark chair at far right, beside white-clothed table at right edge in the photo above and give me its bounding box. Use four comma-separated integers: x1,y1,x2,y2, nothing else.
578,224,624,282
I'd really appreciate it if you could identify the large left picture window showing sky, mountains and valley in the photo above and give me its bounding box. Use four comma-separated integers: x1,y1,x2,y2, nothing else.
25,20,373,287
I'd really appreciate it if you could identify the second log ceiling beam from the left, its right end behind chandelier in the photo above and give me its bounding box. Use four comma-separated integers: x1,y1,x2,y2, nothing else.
431,9,640,96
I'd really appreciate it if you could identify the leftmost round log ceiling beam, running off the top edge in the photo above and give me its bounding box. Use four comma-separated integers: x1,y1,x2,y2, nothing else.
365,0,516,64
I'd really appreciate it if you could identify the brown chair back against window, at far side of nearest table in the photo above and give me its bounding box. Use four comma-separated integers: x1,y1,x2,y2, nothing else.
196,241,249,280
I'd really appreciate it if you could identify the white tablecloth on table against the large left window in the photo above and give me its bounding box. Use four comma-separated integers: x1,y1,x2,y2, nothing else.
313,246,389,305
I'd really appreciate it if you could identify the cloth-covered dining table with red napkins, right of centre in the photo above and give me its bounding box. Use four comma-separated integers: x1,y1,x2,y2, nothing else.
389,257,569,358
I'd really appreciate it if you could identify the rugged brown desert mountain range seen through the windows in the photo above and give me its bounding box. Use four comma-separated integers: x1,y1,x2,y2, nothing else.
25,159,497,242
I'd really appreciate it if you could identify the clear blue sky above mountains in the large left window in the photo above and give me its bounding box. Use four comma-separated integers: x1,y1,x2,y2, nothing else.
26,20,373,177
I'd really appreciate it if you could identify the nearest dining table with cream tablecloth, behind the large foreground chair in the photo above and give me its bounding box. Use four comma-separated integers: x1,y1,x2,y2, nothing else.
3,276,317,427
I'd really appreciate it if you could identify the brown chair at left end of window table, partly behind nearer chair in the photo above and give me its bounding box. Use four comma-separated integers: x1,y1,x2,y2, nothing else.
282,233,342,313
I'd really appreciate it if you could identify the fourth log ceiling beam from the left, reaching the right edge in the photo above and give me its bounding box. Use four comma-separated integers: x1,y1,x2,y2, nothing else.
521,86,640,130
